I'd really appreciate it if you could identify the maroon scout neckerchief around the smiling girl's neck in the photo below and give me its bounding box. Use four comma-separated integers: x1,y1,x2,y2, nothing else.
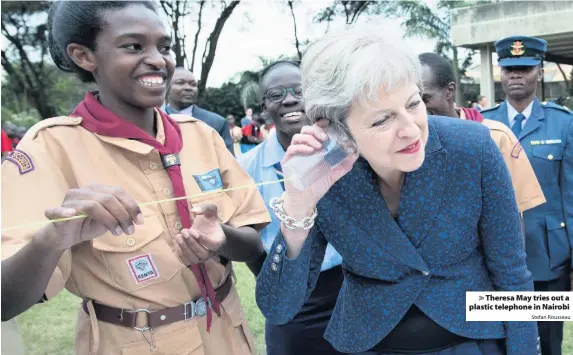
72,92,221,330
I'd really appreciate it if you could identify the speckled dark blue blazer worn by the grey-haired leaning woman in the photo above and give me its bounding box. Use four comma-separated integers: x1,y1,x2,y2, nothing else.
256,116,538,355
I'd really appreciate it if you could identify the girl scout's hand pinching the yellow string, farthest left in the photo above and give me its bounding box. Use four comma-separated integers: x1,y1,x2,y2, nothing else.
45,185,143,250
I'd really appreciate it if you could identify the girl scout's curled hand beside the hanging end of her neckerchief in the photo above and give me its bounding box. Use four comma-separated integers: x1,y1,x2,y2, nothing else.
175,204,227,265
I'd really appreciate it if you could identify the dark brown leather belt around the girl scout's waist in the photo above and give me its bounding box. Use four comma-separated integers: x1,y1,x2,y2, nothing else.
82,276,233,331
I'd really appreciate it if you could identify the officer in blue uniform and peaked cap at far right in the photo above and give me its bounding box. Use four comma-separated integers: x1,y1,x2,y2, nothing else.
482,36,573,355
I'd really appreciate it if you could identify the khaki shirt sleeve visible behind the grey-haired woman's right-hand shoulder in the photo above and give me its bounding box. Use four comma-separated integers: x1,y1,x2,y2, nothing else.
460,110,546,213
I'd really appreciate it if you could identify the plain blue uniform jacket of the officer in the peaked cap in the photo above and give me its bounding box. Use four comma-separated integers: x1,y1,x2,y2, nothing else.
482,99,573,281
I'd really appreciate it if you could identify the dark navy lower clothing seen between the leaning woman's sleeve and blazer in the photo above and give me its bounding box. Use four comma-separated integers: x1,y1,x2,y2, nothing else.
265,266,344,355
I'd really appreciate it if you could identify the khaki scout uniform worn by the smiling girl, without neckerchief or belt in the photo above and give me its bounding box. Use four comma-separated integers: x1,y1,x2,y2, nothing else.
2,115,270,355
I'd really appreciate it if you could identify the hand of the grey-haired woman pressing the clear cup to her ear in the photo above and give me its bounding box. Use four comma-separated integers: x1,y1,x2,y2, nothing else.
282,120,358,220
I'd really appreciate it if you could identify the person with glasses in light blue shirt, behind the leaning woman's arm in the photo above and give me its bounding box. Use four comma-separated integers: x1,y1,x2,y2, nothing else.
239,61,343,355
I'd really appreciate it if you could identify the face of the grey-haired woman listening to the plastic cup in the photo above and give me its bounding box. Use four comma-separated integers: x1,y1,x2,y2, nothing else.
347,83,428,172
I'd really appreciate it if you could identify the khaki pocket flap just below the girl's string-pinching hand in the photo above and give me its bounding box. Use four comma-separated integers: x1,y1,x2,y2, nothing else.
92,214,163,253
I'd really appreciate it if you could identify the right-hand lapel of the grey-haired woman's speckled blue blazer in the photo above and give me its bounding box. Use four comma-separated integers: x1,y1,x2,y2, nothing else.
398,121,447,247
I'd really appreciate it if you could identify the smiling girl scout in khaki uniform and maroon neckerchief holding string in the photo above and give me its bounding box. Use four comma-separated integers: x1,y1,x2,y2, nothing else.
2,1,269,355
